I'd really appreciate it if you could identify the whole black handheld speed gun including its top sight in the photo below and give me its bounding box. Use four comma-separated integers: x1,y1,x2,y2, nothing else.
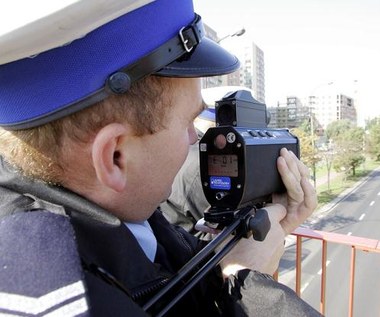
199,90,299,224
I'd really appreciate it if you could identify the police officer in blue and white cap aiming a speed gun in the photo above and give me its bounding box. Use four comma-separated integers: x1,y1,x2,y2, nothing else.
0,0,317,316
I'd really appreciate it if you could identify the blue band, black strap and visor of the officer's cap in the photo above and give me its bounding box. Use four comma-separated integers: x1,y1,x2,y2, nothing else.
0,0,239,130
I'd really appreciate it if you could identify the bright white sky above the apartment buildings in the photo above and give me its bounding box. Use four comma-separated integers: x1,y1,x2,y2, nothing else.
194,0,380,126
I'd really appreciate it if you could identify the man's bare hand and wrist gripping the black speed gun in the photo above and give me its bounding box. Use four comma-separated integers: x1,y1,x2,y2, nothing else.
220,148,317,276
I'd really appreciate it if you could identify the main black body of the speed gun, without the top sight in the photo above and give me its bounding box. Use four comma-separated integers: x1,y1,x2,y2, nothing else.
199,126,299,210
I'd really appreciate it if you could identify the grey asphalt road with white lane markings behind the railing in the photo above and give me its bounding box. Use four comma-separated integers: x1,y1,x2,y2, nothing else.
280,171,380,317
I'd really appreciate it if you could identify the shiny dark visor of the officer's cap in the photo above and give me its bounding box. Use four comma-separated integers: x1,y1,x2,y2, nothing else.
156,37,240,77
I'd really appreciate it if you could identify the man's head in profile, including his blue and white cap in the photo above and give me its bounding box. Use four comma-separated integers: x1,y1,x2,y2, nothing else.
0,0,239,219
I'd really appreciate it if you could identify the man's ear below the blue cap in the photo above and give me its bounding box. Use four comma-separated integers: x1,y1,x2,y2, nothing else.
92,123,130,192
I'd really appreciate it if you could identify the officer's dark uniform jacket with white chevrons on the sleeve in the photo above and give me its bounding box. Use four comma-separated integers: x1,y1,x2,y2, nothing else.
0,160,319,317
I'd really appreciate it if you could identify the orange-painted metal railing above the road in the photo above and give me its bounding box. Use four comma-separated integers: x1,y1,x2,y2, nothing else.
284,227,380,317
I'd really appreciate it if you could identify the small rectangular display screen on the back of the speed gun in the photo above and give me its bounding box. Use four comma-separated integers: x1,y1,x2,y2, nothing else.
208,154,238,177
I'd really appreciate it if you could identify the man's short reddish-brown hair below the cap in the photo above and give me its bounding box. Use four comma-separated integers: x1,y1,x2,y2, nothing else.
0,76,174,184
